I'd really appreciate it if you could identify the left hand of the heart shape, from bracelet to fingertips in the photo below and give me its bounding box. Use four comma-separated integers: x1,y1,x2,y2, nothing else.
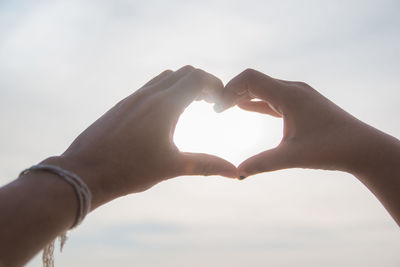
45,66,237,207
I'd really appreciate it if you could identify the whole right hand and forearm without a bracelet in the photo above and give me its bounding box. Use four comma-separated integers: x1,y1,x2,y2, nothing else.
215,69,400,225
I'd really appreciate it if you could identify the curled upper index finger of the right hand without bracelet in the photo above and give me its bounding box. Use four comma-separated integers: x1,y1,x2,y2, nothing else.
214,69,286,112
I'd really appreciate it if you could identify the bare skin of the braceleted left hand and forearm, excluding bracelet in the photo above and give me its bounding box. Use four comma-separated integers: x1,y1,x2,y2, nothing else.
0,66,237,266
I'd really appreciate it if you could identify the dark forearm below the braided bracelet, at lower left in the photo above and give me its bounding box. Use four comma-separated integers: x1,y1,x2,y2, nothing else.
0,168,78,266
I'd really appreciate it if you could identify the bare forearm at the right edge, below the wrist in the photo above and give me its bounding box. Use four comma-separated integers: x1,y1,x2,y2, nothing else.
350,125,400,226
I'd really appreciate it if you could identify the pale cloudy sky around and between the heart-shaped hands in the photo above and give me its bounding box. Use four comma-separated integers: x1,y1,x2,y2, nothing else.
0,0,400,267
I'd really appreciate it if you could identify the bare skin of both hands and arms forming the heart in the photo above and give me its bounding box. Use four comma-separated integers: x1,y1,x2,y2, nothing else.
0,66,400,266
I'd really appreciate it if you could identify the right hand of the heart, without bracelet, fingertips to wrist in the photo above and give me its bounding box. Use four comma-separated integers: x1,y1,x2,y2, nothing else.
216,69,376,178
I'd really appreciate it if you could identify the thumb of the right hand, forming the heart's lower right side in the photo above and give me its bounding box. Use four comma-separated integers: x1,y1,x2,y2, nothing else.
238,146,293,180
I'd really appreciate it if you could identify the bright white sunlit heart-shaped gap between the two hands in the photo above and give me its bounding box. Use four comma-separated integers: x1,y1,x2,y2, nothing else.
174,101,283,165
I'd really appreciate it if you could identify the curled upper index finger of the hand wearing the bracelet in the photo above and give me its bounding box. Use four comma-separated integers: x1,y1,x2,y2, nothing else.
167,69,224,111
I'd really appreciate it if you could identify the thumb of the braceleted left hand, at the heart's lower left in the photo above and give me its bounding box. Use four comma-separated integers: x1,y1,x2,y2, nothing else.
182,152,237,178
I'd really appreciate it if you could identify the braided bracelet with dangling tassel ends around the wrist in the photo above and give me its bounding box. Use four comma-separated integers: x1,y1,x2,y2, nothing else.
19,164,92,267
